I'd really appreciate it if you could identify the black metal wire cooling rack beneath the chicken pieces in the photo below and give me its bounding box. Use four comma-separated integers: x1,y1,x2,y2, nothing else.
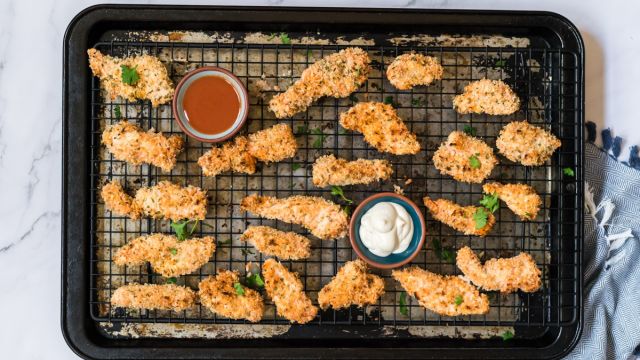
90,38,582,327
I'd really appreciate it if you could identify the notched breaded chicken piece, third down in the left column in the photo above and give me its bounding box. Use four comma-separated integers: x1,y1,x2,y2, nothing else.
102,181,207,221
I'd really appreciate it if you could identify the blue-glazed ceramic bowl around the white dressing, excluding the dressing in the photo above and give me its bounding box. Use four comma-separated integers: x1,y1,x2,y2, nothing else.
349,192,426,269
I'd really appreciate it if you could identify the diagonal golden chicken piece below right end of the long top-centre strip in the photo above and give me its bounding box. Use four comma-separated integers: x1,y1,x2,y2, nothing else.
340,102,420,155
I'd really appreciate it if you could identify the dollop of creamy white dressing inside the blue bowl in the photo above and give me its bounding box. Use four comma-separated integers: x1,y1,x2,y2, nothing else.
359,202,413,257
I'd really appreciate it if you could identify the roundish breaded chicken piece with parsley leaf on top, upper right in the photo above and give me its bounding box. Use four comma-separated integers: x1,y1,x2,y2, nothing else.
433,131,498,183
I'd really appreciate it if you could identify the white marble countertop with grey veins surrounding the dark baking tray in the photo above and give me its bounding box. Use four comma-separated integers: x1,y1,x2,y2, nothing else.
0,0,640,359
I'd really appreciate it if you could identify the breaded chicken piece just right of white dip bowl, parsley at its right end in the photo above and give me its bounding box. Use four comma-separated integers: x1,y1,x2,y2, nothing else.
423,196,496,236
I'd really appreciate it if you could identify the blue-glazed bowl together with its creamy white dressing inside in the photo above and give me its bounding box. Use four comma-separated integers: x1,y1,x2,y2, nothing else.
349,192,425,269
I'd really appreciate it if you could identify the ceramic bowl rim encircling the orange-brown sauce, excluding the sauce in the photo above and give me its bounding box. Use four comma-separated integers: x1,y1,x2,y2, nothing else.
173,66,249,143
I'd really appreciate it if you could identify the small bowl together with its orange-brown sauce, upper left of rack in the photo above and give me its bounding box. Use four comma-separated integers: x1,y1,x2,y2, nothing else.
173,66,249,143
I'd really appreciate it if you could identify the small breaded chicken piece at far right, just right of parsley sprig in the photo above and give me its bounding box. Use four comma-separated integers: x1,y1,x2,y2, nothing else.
482,182,542,220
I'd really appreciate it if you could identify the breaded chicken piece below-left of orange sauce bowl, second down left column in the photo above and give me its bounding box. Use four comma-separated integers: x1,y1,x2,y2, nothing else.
102,121,183,172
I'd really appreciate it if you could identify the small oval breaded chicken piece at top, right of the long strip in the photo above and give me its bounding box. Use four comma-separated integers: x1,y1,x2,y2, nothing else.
387,53,444,90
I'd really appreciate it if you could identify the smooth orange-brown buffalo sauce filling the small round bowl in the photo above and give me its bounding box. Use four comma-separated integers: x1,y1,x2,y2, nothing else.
182,76,240,135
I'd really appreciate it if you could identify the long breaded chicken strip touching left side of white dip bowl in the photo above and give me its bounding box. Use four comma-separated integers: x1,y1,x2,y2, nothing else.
240,194,349,240
